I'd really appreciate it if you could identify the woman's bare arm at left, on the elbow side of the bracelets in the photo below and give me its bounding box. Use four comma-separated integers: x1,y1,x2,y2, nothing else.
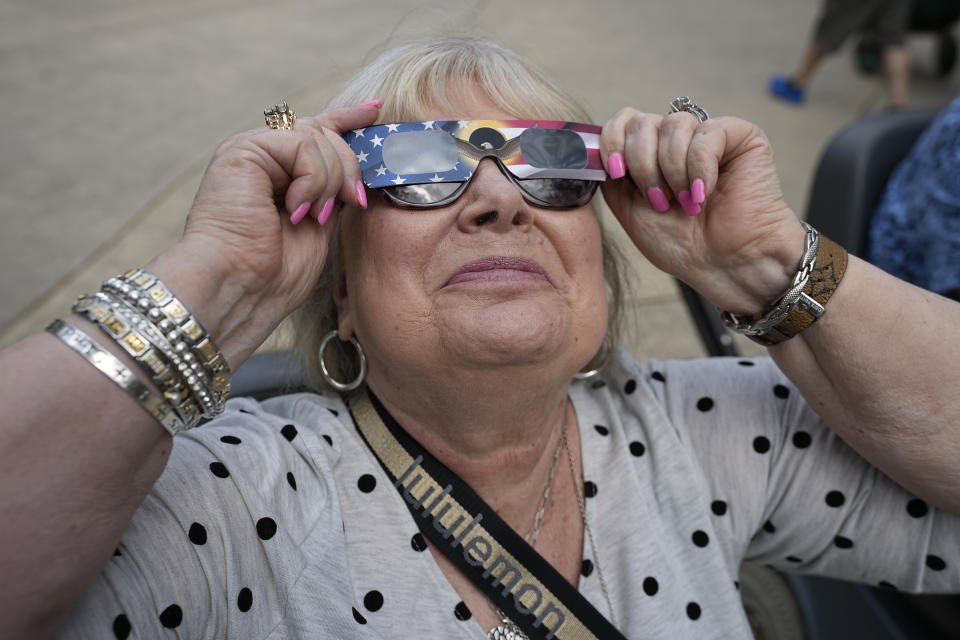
0,316,172,637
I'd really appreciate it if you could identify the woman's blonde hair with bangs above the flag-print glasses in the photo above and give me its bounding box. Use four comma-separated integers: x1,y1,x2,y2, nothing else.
293,37,622,388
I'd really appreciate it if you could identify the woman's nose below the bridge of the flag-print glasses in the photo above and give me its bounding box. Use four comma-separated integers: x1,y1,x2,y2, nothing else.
457,158,533,232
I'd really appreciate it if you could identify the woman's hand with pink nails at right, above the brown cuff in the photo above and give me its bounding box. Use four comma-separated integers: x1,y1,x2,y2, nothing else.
600,108,806,313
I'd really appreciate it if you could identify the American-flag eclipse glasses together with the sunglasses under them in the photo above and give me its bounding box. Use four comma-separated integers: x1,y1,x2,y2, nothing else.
344,120,607,209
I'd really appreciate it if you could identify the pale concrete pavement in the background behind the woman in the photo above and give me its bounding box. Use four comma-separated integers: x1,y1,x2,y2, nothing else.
0,0,958,358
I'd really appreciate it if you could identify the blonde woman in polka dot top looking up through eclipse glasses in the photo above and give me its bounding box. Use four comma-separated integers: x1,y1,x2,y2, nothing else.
0,40,960,638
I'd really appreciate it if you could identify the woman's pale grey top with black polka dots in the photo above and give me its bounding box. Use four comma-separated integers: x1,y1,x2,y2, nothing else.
57,352,960,640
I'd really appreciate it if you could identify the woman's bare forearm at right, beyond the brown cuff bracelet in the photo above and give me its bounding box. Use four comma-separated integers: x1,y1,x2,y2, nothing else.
770,256,960,512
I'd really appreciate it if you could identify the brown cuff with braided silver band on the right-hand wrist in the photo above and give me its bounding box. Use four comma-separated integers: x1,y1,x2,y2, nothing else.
720,222,847,347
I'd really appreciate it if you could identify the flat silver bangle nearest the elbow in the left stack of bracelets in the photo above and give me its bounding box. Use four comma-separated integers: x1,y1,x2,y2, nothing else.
47,319,184,436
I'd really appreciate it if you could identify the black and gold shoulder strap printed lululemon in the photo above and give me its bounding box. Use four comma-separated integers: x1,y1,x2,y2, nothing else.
351,391,624,640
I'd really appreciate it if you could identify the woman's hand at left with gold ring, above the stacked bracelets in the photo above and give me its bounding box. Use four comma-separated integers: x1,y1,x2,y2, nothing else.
146,102,379,368
